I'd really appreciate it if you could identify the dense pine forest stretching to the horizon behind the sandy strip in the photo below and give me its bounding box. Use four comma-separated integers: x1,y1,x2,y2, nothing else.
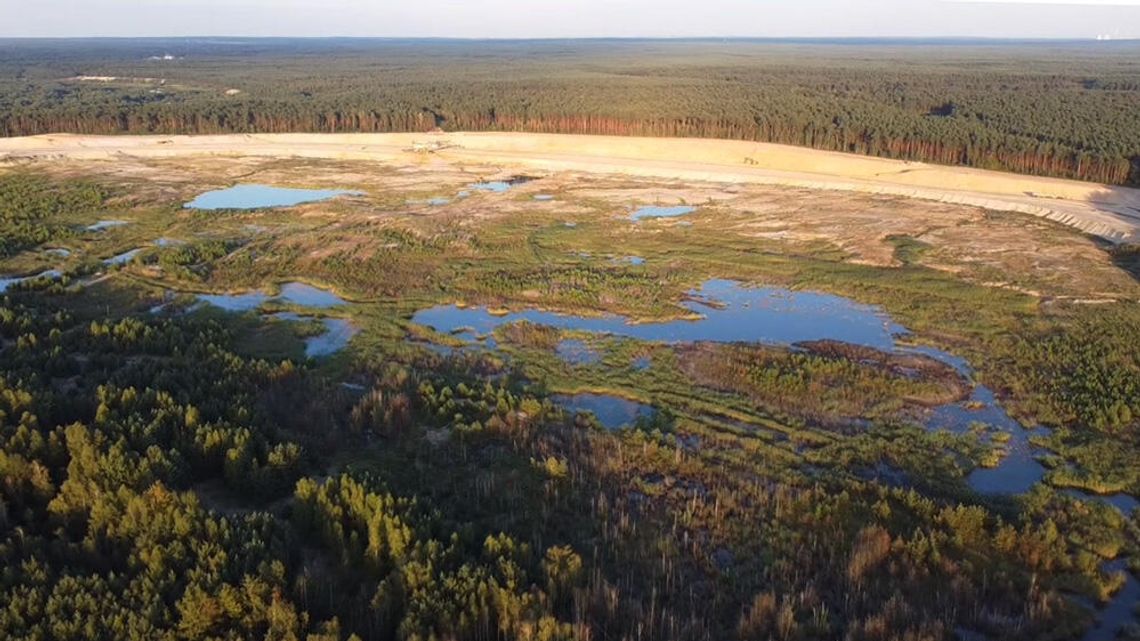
0,40,1140,185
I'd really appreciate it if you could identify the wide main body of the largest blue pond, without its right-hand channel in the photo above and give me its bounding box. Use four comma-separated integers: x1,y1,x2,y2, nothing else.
412,279,905,351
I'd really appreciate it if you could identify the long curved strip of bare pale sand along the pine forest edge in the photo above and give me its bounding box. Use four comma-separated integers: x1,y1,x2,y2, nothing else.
0,132,1140,243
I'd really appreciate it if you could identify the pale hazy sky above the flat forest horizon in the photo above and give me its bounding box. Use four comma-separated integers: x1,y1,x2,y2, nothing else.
0,0,1140,39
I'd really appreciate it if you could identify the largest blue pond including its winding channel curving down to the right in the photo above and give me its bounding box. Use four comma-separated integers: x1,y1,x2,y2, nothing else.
413,279,1137,509
